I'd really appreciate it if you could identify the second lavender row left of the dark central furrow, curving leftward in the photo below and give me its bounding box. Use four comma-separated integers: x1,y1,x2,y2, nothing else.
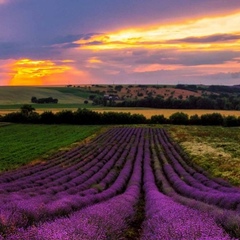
2,127,140,231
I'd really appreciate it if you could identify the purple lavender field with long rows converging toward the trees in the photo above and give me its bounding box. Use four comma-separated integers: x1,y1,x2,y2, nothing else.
0,127,240,240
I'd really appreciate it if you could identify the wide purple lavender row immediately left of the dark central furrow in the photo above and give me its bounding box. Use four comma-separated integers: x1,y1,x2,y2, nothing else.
6,129,143,240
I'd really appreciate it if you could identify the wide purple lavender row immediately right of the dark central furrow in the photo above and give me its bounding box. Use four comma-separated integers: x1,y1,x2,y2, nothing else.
141,129,230,240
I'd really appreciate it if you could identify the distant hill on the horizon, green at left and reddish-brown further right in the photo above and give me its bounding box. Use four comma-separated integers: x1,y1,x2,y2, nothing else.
0,84,240,105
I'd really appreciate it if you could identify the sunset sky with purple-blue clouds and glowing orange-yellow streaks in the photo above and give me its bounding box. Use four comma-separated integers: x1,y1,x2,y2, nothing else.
0,0,240,86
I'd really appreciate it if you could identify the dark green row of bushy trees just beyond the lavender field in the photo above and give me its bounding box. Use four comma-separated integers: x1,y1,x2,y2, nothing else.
0,105,240,127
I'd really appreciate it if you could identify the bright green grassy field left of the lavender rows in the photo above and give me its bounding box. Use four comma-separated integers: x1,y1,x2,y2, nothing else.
0,124,102,171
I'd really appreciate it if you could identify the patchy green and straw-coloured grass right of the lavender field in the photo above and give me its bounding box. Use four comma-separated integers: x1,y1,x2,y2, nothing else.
167,125,240,186
